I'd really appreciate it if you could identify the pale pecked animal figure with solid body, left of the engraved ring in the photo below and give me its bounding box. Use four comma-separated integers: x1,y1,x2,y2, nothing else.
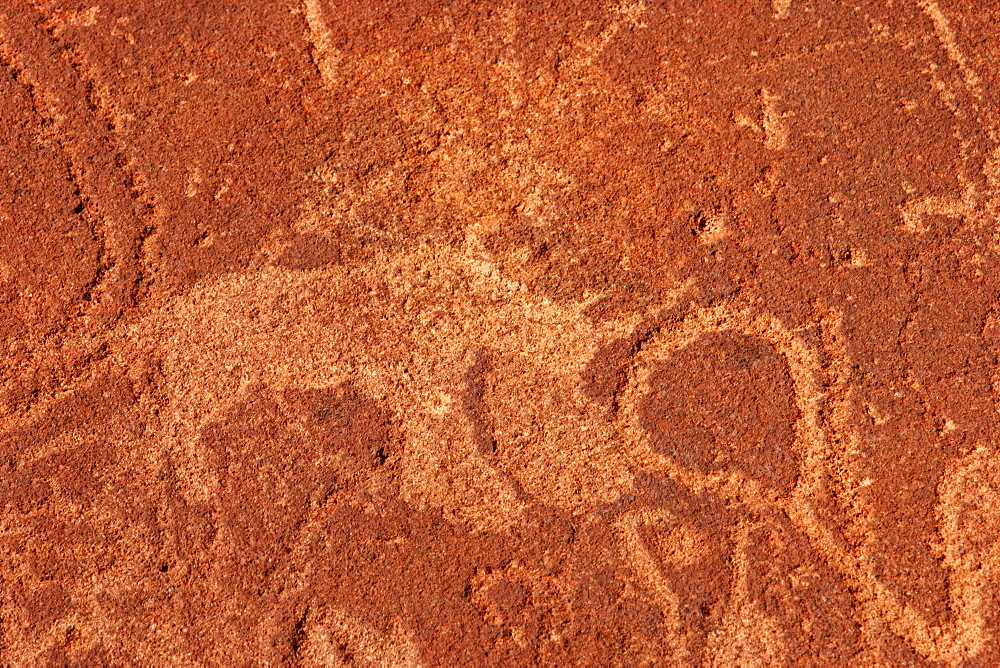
113,237,683,529
